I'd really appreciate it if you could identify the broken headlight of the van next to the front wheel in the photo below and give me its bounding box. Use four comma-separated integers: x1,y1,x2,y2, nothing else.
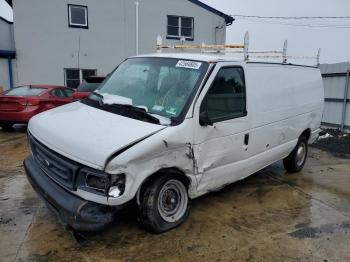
77,168,125,197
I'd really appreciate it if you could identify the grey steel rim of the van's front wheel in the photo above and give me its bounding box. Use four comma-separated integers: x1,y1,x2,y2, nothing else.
158,179,188,223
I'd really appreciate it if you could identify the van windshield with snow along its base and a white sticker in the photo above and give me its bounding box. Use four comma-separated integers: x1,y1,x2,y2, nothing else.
89,58,208,119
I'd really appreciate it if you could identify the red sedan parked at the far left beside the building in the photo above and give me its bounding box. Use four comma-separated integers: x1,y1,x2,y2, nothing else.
0,85,74,129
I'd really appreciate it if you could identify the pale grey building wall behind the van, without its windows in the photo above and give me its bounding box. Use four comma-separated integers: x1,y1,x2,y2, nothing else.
13,0,226,85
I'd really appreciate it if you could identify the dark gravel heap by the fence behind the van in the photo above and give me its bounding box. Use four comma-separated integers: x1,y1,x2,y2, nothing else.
312,129,350,159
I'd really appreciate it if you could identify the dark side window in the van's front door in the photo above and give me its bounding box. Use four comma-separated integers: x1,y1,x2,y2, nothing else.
205,67,246,122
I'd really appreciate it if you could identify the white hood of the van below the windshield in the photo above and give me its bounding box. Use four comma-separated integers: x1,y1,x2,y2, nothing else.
28,102,166,169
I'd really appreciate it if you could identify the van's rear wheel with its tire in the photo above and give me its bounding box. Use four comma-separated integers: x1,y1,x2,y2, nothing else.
283,136,308,173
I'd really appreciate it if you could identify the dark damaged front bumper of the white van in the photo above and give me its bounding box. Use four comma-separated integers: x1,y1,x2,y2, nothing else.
24,155,118,231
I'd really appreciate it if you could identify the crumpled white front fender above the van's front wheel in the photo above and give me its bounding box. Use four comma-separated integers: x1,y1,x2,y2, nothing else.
105,121,198,205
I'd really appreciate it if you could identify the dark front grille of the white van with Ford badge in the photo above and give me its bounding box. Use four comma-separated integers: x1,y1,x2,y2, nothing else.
28,133,83,190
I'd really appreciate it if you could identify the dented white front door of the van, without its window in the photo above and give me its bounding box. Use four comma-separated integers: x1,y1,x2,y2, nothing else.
194,62,251,195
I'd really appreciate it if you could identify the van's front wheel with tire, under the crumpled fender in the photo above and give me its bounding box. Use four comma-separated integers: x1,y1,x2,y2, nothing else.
140,175,190,234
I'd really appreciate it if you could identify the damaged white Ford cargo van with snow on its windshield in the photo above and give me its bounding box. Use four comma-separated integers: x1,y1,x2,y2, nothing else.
24,48,324,233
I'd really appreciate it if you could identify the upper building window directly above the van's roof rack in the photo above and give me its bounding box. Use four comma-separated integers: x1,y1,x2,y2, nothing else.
167,15,194,40
